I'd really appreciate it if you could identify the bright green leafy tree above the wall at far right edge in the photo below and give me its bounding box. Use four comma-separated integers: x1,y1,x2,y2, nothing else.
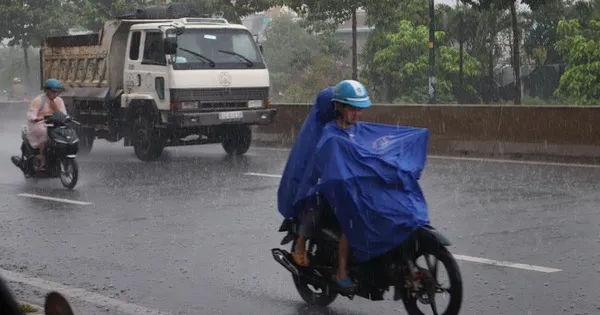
555,19,600,105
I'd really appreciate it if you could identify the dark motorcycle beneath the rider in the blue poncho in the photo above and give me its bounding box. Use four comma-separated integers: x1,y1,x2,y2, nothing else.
271,212,463,315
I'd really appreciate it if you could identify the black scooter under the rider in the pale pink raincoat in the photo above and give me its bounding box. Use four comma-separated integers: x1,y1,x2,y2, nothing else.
11,112,79,189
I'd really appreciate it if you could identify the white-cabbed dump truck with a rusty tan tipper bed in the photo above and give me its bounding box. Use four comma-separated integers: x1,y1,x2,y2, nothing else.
40,17,277,161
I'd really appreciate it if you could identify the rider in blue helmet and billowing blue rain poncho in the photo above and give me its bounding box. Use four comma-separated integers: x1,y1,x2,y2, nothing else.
277,80,429,289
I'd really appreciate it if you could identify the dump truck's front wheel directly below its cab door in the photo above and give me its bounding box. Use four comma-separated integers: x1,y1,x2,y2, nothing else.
132,115,165,162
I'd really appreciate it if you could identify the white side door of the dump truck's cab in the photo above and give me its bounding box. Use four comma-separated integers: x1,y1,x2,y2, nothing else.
122,30,169,110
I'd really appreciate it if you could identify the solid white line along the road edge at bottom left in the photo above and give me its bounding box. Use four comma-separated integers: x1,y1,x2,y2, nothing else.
0,269,169,315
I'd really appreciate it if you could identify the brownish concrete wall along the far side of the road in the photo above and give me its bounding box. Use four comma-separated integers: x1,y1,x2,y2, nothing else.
255,104,600,163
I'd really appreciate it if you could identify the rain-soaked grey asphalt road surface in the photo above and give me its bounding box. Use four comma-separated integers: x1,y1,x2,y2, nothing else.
0,104,600,315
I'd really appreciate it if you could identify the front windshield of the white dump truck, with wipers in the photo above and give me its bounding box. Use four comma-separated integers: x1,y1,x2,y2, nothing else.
173,28,266,70
